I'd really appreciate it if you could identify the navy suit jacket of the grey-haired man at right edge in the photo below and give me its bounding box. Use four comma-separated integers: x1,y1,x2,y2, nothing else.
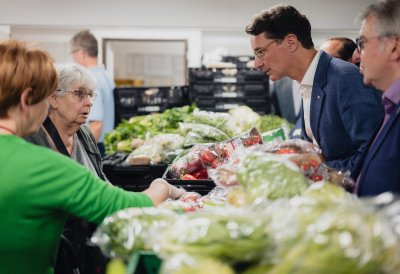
353,101,400,196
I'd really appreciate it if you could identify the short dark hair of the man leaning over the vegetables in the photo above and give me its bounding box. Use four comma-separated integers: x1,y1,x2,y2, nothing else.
246,5,314,49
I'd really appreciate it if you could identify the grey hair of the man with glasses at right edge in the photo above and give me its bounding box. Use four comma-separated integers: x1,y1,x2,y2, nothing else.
358,0,400,37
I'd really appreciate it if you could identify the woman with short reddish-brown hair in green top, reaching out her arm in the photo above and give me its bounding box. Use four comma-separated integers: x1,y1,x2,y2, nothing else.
0,41,184,274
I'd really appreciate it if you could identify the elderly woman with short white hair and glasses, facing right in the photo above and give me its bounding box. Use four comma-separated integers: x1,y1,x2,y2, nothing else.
26,64,106,180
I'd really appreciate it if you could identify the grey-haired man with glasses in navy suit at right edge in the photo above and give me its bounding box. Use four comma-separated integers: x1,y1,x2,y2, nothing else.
353,0,400,196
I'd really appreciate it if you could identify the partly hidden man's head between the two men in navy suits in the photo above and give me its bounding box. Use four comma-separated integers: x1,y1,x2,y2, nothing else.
320,37,357,64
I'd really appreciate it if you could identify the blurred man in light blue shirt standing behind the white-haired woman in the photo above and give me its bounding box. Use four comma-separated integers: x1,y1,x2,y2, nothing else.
70,30,115,157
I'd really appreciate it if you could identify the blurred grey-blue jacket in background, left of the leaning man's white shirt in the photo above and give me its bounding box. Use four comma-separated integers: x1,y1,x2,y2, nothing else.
271,77,298,124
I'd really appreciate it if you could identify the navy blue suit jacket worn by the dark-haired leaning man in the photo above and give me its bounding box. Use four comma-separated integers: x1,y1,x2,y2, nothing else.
300,52,384,171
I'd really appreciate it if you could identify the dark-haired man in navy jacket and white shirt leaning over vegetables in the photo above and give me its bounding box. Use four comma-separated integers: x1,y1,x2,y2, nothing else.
246,5,383,171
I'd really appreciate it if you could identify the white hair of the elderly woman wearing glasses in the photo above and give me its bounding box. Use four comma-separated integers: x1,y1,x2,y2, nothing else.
56,64,96,97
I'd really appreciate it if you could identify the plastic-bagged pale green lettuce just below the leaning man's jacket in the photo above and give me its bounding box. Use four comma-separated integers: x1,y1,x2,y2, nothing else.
236,152,309,203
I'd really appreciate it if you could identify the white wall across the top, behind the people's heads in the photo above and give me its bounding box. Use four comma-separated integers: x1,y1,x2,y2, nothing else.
0,0,373,70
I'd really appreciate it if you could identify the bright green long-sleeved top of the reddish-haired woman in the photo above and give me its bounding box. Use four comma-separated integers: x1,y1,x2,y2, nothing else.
0,135,153,274
